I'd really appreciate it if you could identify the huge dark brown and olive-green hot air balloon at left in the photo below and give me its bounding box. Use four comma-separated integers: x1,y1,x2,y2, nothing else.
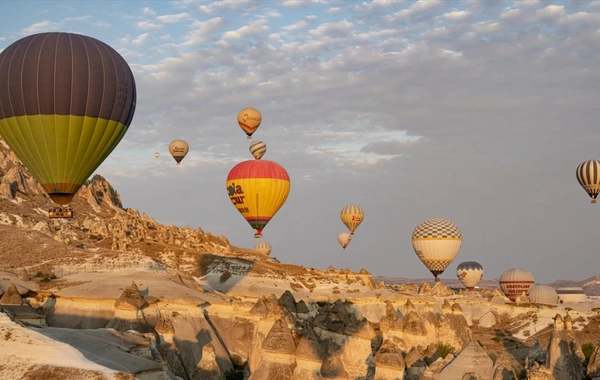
0,33,136,211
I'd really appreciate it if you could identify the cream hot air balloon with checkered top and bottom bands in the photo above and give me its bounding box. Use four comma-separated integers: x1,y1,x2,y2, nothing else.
412,218,462,282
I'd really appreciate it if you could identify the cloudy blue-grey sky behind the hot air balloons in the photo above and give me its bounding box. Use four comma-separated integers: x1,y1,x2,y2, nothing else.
0,0,600,283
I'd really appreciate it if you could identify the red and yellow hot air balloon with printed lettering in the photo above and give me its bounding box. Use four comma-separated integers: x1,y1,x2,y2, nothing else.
226,160,290,238
